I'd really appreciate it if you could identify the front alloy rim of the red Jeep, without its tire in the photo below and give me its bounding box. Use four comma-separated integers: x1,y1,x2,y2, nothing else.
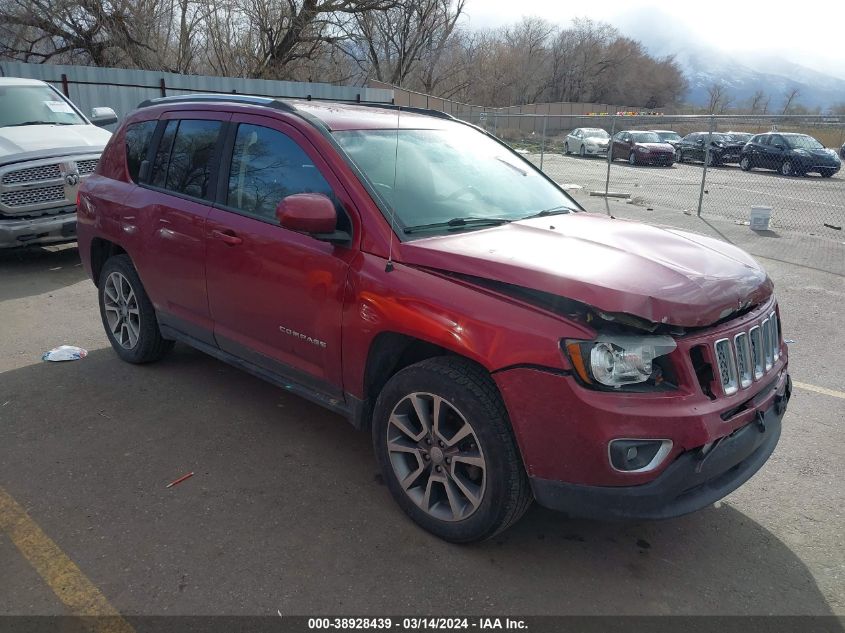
385,392,487,521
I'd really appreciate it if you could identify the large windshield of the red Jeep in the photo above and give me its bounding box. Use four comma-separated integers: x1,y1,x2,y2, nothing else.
334,124,578,232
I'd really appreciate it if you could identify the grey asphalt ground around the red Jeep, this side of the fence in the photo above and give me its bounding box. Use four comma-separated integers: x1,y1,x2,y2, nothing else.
0,228,845,615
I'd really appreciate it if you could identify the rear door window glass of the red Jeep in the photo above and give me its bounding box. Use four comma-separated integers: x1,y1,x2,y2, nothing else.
152,119,223,198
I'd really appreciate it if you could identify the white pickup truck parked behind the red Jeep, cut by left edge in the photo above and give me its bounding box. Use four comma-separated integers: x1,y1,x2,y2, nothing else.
0,77,117,248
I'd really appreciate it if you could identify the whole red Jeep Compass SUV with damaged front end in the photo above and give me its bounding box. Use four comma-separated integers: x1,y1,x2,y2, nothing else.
78,95,791,542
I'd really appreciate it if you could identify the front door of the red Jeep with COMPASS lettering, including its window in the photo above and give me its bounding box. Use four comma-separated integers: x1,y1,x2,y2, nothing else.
206,115,357,390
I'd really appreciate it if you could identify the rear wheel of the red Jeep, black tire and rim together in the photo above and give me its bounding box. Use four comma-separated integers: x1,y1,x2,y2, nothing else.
97,255,173,364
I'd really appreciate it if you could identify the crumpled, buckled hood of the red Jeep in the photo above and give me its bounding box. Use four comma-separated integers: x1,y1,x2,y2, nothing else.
401,213,773,327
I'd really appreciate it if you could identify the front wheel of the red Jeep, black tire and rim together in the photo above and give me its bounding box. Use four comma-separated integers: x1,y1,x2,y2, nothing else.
373,356,533,543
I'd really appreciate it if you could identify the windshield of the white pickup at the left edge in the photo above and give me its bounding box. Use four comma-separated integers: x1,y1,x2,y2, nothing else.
0,85,85,127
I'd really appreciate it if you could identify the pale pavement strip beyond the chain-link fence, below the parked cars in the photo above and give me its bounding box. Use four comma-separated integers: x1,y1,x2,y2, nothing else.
529,154,845,233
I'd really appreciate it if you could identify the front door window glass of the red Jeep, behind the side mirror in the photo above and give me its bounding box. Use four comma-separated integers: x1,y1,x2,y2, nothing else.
227,124,343,223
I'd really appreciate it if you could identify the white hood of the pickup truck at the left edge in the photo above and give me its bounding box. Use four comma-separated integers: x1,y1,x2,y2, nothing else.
0,125,111,159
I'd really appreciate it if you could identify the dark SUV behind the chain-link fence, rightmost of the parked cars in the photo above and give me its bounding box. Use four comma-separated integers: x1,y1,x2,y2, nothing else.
739,132,842,178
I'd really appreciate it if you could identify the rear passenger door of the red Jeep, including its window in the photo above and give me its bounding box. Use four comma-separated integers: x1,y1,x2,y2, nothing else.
129,112,230,344
